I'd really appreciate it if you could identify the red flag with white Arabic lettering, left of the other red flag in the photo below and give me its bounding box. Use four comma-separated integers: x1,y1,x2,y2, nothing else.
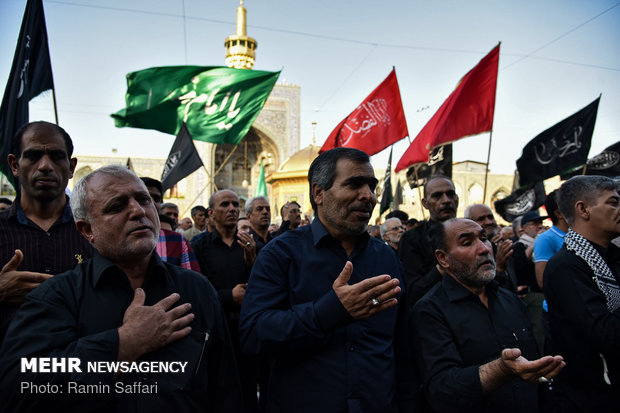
319,69,409,155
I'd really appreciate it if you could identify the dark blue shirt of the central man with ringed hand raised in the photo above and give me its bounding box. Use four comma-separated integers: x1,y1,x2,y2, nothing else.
240,218,416,413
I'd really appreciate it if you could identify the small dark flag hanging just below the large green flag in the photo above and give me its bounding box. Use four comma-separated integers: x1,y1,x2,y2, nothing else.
161,124,202,192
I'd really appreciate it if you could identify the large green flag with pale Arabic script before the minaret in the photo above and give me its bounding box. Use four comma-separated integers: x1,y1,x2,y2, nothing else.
111,66,280,145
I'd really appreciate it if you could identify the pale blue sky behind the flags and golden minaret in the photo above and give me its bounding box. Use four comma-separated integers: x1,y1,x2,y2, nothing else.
0,0,620,174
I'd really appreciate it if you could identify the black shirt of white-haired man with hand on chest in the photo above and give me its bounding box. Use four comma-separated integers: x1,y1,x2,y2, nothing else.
0,252,241,413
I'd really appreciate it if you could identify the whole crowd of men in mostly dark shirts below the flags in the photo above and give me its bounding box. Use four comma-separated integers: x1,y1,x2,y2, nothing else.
0,122,620,413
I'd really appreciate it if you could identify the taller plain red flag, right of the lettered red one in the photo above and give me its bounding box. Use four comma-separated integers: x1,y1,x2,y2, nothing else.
395,45,499,172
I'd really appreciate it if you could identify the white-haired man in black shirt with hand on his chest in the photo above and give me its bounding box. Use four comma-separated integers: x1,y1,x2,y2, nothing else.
0,165,240,413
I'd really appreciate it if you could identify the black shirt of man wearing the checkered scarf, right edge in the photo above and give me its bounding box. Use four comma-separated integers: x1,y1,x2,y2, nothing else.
543,243,620,412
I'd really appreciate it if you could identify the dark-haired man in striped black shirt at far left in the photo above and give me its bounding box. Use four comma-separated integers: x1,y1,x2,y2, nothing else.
0,122,92,343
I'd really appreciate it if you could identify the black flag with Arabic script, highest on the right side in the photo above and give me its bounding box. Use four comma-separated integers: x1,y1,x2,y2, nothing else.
517,97,601,186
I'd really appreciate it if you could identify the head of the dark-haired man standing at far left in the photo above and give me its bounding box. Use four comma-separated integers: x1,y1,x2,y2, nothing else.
8,125,77,202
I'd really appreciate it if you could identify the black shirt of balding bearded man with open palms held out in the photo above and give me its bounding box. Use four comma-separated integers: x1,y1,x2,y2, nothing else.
410,275,538,413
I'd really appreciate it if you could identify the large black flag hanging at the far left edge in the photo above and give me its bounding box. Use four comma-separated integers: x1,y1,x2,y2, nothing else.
0,0,54,187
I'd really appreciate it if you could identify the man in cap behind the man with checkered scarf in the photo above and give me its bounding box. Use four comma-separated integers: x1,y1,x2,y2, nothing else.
511,211,548,352
